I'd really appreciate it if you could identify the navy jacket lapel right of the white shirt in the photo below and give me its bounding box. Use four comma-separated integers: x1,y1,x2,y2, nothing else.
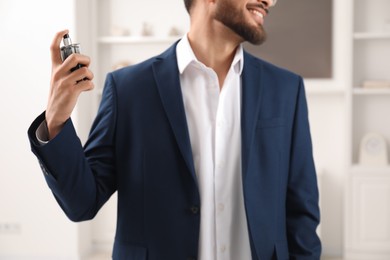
241,52,263,180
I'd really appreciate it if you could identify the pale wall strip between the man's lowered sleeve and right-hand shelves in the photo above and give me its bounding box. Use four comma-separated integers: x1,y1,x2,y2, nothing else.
307,94,347,256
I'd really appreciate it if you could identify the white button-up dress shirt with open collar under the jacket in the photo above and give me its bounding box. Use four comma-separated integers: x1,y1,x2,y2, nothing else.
176,37,251,260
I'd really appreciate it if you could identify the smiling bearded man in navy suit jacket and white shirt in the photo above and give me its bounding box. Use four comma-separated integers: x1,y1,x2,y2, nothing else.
29,0,321,260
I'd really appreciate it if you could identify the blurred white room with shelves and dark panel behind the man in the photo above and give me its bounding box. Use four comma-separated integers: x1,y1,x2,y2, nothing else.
0,0,390,260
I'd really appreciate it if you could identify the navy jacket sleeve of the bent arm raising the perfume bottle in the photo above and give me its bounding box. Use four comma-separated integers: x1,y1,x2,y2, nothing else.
28,73,116,221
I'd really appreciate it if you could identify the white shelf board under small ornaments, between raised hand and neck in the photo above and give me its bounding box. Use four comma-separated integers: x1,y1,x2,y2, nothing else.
98,36,182,44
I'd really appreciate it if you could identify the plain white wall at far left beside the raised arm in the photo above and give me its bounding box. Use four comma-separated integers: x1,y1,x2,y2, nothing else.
0,0,88,260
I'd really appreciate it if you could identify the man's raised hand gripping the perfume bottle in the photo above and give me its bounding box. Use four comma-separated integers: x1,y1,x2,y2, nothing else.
46,30,94,140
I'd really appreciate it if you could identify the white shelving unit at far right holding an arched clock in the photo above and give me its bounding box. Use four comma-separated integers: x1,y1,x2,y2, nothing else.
344,0,390,260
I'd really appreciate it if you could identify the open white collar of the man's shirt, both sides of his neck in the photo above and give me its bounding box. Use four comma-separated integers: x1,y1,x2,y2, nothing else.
176,34,244,75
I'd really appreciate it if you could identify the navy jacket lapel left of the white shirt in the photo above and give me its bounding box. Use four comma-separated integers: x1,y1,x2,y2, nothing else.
153,44,197,186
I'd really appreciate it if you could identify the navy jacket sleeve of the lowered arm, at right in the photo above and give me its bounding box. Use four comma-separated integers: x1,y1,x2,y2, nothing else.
286,78,321,260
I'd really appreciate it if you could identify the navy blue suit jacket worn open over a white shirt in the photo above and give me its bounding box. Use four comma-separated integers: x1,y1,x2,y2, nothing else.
29,42,321,260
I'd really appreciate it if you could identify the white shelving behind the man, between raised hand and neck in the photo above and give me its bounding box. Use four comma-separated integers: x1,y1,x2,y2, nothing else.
89,0,189,99
